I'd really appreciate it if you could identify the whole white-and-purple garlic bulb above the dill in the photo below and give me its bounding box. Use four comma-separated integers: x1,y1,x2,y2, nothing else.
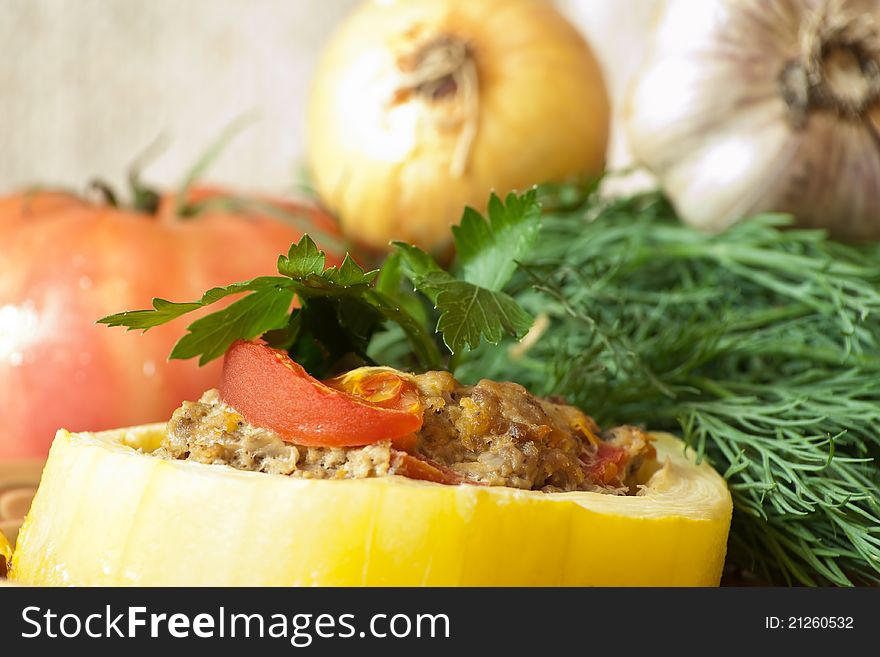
625,0,880,240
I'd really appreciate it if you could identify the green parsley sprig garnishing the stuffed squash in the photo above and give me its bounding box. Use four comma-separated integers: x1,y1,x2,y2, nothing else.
98,190,541,376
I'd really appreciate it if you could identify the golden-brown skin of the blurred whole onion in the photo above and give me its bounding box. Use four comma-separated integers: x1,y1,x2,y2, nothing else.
308,0,609,252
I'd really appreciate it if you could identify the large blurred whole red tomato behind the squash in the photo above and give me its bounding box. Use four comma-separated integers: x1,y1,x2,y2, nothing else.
0,183,339,459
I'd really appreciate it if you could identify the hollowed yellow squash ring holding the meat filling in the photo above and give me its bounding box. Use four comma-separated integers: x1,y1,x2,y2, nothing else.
10,425,731,586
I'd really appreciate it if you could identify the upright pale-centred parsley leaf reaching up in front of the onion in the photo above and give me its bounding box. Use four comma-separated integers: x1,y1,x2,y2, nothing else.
452,189,541,292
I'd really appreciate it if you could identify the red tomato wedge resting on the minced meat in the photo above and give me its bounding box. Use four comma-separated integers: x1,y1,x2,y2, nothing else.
220,340,422,447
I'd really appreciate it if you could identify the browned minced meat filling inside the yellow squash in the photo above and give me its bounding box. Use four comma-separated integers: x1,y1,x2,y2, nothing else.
155,372,653,493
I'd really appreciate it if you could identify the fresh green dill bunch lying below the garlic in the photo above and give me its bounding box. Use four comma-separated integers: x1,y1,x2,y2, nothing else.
457,188,880,585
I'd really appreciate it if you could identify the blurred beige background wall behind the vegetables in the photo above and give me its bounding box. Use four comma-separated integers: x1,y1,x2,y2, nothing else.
0,0,657,193
